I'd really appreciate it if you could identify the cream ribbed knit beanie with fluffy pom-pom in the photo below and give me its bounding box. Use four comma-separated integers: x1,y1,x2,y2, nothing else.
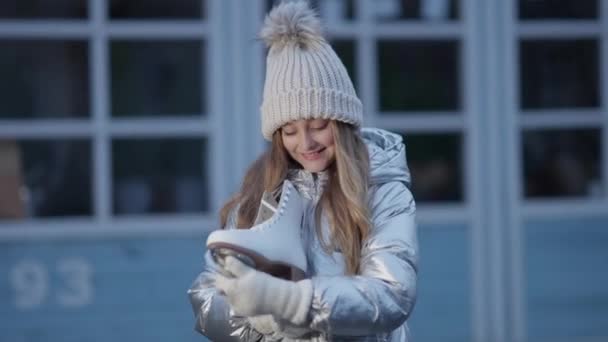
260,1,363,140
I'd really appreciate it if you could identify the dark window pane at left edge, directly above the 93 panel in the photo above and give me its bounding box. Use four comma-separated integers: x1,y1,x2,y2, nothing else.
0,140,92,219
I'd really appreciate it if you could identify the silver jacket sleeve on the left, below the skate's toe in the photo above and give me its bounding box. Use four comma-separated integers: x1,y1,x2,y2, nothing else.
188,210,263,342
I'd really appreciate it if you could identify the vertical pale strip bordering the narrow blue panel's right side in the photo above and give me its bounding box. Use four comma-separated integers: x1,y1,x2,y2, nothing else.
466,0,488,342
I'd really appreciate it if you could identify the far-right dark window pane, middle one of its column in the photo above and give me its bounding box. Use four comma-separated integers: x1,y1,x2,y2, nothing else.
520,39,599,109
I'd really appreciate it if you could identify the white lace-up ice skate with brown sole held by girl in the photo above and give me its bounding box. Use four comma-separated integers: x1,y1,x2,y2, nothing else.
207,180,306,280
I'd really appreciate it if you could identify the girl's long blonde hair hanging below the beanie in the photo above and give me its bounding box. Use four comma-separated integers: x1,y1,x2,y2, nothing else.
220,120,370,274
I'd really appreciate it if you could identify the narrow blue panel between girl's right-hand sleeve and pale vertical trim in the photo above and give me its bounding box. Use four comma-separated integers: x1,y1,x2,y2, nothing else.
408,226,473,342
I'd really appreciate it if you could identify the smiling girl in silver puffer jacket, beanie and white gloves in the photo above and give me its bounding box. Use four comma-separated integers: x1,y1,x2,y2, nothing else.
189,1,418,341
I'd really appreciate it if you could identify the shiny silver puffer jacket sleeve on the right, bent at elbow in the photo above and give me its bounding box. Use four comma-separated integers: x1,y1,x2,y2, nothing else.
309,182,418,336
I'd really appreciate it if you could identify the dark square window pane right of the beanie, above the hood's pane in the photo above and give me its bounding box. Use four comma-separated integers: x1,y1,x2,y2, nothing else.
378,40,460,111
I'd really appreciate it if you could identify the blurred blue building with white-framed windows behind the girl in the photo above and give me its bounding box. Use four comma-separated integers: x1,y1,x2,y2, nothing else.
0,0,608,342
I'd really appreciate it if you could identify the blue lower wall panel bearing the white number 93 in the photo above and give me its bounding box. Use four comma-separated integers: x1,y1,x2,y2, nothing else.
0,236,209,342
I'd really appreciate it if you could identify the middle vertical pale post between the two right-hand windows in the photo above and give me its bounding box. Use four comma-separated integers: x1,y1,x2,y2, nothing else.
481,1,511,342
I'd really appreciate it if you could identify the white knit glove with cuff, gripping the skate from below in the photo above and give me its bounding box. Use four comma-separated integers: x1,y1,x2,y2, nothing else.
215,256,312,325
